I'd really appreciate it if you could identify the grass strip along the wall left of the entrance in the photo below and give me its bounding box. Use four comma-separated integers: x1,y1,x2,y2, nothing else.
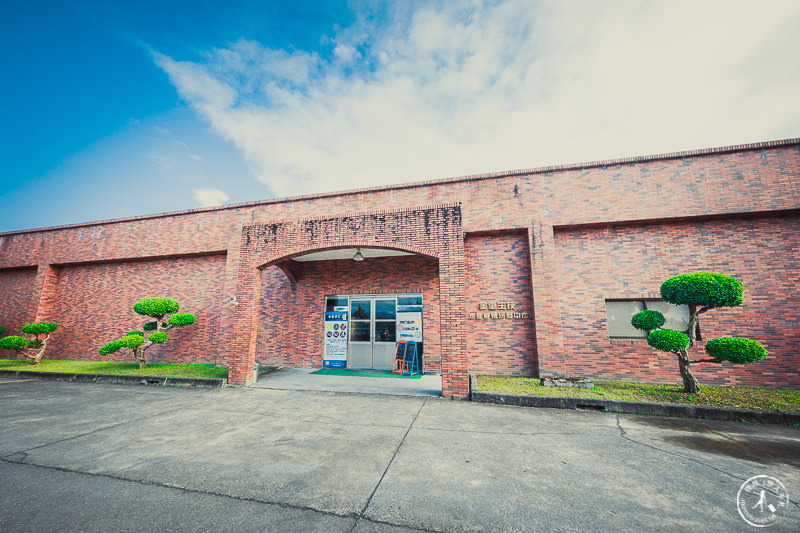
0,359,228,379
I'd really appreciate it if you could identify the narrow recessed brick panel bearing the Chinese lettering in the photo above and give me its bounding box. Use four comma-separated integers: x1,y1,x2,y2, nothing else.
464,232,538,376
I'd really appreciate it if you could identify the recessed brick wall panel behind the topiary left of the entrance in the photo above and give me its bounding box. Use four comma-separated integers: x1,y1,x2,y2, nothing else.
47,255,229,365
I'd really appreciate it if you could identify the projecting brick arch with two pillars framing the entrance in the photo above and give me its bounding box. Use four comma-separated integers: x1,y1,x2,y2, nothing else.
229,204,469,397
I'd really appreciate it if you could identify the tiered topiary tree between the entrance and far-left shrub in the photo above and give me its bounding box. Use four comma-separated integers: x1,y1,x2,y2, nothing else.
100,298,197,368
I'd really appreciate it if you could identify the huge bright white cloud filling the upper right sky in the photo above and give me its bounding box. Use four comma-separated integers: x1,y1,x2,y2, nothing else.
155,0,800,201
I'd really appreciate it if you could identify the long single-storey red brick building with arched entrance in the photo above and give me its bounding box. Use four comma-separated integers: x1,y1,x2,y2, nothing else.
0,139,800,397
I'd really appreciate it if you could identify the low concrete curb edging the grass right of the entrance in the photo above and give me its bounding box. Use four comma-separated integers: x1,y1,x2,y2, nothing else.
469,375,800,426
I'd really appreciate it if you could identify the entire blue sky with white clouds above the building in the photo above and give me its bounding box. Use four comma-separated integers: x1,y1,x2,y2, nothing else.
0,0,800,232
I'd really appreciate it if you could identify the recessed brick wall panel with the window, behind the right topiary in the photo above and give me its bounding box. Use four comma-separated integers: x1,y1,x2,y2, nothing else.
555,216,800,388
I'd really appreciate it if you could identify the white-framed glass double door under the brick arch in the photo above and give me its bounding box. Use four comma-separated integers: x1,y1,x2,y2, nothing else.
347,296,397,370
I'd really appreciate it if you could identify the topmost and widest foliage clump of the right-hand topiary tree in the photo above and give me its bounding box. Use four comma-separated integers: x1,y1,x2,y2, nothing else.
661,272,744,307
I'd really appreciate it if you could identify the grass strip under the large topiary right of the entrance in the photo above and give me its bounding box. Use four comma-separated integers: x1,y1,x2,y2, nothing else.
478,376,800,411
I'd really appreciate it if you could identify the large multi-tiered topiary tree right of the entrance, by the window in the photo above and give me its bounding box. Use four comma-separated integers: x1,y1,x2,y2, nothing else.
631,272,767,393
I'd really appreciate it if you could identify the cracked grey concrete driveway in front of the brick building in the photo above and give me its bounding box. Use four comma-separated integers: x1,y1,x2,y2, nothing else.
0,379,800,532
